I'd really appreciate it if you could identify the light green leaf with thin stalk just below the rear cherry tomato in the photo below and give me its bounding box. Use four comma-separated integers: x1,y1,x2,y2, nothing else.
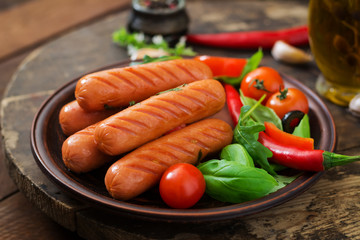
240,90,283,130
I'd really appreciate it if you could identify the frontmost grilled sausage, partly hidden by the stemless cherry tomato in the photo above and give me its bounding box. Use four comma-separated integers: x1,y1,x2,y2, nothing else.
105,119,233,200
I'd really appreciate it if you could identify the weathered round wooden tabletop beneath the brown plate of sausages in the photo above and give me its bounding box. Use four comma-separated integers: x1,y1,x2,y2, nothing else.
0,0,360,239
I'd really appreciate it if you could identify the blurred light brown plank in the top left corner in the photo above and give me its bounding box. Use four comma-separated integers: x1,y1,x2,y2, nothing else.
0,0,130,59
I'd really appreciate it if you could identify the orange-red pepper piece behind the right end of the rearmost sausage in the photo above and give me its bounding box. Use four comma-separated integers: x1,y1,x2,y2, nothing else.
194,55,247,77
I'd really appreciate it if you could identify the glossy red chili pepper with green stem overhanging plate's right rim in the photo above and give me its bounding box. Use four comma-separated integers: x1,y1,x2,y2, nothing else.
258,132,360,172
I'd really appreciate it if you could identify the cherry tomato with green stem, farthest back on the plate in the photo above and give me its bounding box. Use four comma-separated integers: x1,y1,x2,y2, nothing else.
240,67,284,103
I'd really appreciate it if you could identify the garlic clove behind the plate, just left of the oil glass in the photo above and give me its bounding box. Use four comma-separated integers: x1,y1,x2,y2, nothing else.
271,40,313,64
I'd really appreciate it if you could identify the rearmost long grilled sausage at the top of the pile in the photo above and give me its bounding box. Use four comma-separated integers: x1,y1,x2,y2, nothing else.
75,59,212,111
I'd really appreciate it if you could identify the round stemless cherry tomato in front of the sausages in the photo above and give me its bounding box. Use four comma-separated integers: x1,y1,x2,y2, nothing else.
159,163,206,209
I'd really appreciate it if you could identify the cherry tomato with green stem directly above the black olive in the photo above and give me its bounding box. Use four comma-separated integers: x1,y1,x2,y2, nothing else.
265,88,309,119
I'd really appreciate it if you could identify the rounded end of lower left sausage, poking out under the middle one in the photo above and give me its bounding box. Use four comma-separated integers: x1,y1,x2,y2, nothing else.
62,124,113,173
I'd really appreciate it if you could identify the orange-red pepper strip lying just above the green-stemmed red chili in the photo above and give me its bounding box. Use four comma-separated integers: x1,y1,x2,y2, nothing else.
264,122,314,150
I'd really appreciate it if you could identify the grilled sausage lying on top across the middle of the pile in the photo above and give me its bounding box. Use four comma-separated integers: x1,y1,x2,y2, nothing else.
95,79,225,155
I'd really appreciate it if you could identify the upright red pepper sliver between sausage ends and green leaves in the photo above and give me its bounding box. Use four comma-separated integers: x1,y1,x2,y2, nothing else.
224,83,243,126
